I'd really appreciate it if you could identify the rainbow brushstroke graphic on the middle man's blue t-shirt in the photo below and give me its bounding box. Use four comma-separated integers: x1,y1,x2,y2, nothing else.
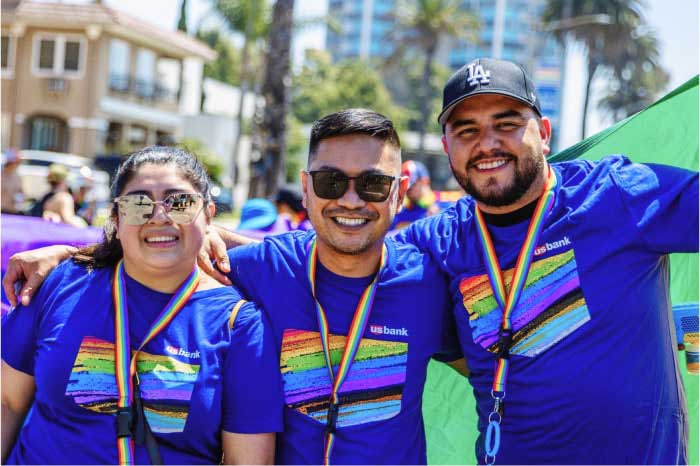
280,329,408,427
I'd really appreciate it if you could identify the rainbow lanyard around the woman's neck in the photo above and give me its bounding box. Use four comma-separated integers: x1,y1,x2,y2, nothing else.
112,259,199,465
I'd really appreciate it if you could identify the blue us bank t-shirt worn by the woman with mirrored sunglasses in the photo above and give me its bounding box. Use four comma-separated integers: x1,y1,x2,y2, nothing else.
2,261,282,464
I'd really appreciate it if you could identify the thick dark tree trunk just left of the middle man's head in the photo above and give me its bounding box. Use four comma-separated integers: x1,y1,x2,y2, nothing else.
248,0,294,198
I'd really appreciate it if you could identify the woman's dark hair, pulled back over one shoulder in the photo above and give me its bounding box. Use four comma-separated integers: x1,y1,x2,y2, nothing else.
73,146,211,268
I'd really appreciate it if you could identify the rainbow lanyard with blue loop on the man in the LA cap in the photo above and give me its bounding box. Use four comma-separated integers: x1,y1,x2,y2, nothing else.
474,167,557,464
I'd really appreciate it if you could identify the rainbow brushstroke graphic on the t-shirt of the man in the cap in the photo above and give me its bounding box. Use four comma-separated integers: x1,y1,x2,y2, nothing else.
459,249,591,357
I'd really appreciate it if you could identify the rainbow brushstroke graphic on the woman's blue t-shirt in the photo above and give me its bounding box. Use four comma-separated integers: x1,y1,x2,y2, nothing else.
66,337,200,433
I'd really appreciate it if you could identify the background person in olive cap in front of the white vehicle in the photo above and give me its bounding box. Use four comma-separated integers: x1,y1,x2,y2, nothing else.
32,163,87,227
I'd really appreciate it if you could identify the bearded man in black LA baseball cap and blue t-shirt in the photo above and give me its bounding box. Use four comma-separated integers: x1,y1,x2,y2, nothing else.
399,58,698,464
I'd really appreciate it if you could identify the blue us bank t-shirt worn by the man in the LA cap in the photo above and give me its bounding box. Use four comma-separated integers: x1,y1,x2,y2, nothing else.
399,156,698,464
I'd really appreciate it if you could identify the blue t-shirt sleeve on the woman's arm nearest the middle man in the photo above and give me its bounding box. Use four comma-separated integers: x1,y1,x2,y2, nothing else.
223,302,283,434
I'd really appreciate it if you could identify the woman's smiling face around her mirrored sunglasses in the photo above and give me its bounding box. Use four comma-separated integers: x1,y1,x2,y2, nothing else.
117,164,214,285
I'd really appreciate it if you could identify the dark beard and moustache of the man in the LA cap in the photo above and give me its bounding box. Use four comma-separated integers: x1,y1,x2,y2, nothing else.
450,152,544,207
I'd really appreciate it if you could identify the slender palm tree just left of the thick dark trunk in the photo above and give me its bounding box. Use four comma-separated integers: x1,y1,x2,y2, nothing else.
214,0,269,188
